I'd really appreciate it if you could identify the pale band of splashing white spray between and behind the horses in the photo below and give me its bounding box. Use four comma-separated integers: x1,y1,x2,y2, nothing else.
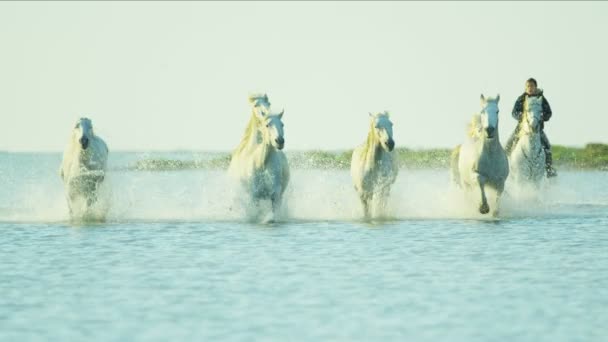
0,153,608,222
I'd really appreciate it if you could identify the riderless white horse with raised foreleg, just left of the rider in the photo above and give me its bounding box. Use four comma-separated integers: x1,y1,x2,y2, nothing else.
451,94,509,216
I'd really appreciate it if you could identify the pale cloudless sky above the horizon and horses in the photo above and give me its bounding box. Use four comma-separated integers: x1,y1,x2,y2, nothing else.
0,1,608,151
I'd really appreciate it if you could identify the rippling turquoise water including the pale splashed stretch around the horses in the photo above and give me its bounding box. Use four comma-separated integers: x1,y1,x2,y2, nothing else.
0,153,608,341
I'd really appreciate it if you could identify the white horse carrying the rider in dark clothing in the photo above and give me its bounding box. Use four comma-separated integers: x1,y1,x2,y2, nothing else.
509,96,545,188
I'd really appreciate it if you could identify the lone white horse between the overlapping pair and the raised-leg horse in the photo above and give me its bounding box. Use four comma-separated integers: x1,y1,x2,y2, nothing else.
350,112,399,218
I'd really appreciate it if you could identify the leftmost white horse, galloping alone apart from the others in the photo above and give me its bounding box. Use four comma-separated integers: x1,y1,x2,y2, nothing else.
60,118,108,220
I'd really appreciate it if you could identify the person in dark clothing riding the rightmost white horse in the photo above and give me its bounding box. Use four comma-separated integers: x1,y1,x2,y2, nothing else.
505,78,557,177
